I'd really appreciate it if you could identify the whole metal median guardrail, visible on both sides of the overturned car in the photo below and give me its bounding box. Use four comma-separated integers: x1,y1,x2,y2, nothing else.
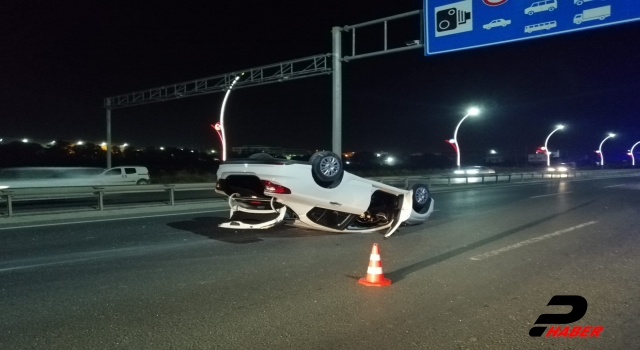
0,169,640,217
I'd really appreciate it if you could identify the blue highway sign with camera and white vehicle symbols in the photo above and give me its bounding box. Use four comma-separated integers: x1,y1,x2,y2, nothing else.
424,0,640,55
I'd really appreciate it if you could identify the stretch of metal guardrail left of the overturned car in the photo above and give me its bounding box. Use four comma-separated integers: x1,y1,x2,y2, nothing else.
0,183,215,217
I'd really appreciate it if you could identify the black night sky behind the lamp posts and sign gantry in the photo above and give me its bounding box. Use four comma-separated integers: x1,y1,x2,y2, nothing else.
0,0,640,159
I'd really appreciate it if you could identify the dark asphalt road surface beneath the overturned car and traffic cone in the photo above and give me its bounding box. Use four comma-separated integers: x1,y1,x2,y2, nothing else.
0,177,640,349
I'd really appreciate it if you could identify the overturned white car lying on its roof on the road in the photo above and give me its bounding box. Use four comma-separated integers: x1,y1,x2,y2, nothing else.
216,151,434,237
